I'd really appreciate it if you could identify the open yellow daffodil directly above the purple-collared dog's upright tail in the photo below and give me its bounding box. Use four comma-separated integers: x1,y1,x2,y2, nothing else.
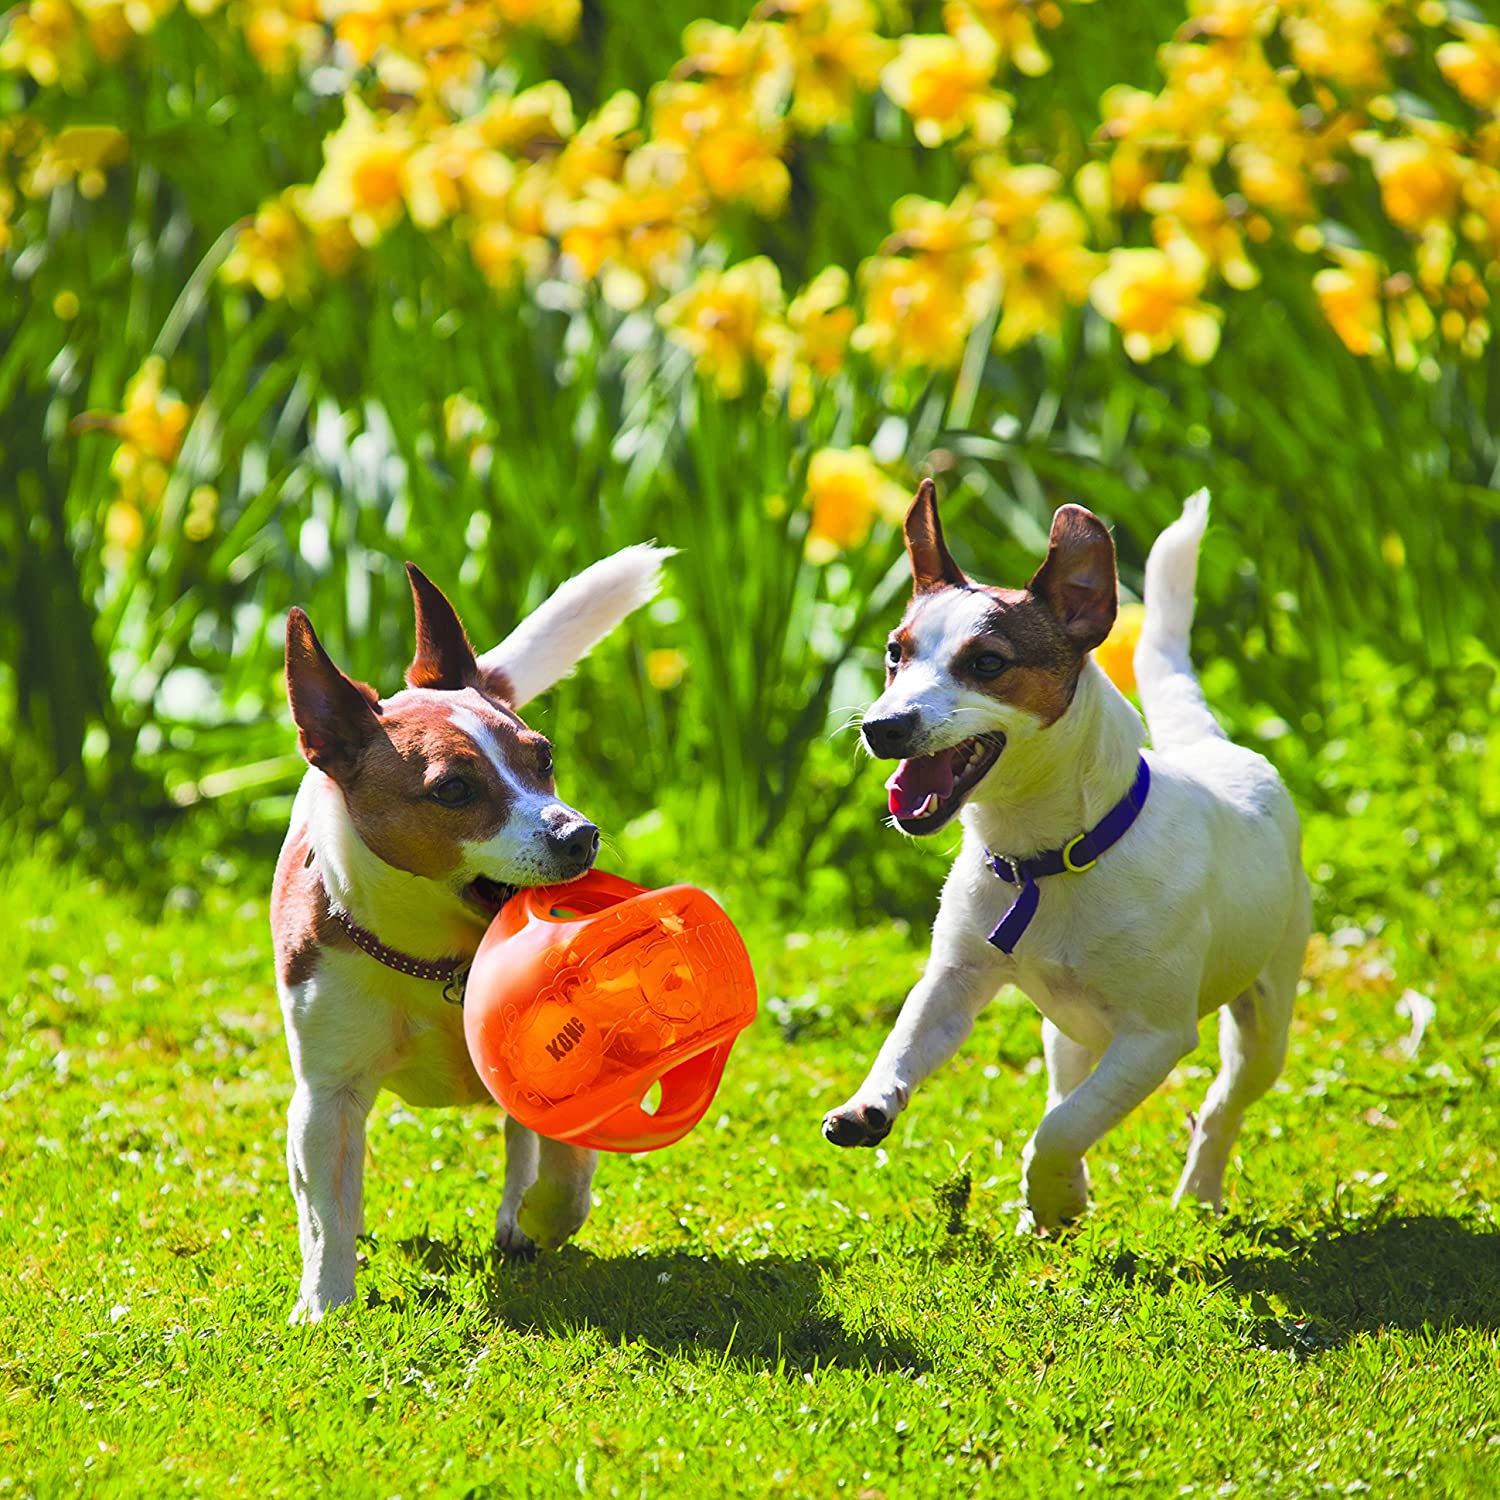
1089,239,1221,365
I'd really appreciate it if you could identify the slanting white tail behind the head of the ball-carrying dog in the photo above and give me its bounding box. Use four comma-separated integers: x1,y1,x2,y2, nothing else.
479,543,675,708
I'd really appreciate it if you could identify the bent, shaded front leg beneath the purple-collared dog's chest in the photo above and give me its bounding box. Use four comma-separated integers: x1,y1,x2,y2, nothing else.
1022,1026,1199,1229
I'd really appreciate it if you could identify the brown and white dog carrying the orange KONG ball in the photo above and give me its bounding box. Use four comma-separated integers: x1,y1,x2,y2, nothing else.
272,546,671,1323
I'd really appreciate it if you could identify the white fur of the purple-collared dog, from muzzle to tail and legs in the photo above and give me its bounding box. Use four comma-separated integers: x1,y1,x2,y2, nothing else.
824,497,1310,1227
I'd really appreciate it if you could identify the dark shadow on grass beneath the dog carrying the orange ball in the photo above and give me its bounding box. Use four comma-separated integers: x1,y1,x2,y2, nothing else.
401,1238,930,1376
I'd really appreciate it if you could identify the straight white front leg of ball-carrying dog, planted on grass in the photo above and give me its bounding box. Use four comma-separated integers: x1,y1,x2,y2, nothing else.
287,1080,375,1323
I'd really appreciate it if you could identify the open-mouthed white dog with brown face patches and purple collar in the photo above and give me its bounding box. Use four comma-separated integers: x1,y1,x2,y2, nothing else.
824,480,1310,1229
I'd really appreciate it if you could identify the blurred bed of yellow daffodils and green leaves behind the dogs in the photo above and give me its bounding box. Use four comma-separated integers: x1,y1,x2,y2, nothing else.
0,0,1500,903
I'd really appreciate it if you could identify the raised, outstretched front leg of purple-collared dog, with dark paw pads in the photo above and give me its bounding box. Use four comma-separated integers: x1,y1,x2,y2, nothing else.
824,954,999,1146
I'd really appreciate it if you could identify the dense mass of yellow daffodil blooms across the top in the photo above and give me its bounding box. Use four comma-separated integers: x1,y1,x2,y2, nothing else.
0,0,1500,554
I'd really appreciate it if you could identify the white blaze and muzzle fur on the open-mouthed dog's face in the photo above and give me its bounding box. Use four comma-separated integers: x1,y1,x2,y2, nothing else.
864,588,1010,755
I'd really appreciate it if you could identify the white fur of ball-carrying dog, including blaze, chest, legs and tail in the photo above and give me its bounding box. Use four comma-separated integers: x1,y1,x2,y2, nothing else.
279,546,671,1323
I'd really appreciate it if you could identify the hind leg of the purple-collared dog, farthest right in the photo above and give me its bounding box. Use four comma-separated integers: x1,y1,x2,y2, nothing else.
1172,893,1308,1209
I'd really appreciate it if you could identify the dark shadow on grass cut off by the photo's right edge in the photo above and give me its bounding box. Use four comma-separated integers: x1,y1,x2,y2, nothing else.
1223,1217,1500,1347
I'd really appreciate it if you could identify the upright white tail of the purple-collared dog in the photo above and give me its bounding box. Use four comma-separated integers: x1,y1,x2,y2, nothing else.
1136,489,1224,749
